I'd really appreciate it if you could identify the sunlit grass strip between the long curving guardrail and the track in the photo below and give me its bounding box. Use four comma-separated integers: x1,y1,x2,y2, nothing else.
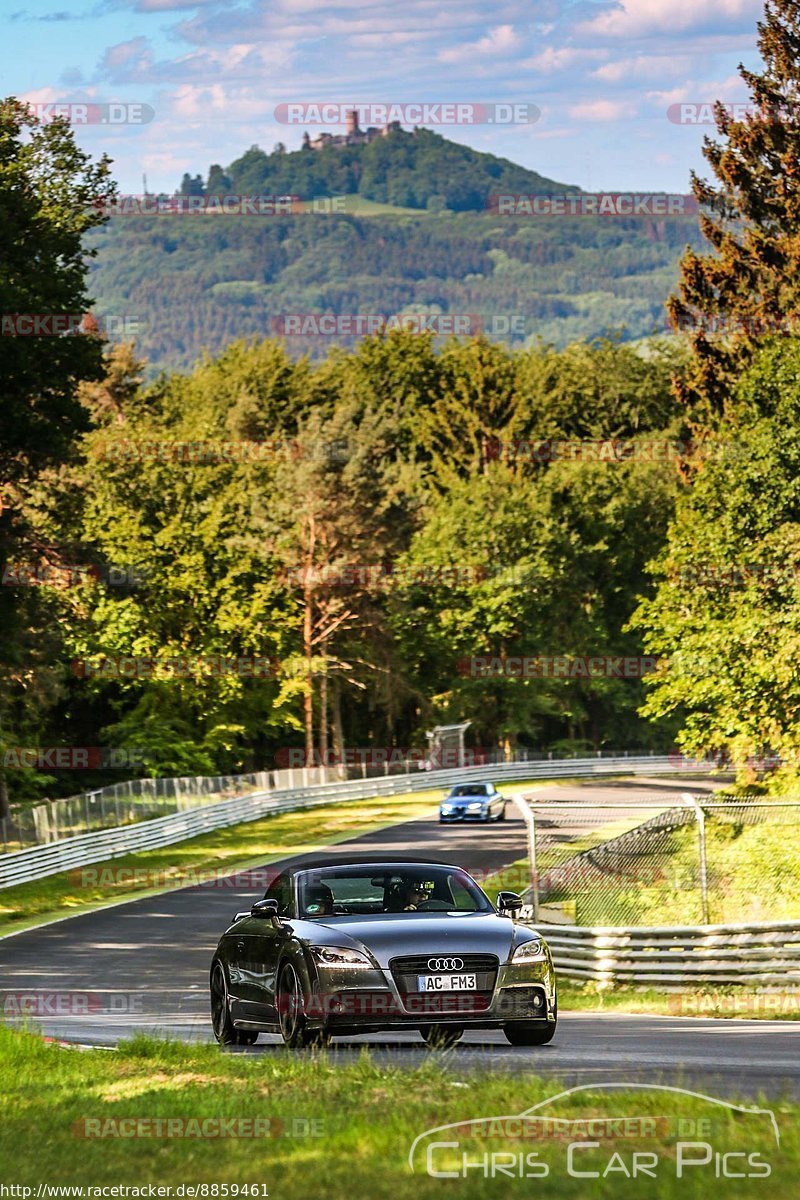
0,790,440,936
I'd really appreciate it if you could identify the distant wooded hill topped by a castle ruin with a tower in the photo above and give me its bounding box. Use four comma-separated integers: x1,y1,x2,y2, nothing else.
84,131,700,368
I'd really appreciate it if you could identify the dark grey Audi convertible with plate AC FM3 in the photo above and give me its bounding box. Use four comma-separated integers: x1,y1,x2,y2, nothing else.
211,859,558,1048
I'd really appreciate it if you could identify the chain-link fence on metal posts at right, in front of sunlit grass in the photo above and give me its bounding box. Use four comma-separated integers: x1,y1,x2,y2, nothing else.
523,794,800,926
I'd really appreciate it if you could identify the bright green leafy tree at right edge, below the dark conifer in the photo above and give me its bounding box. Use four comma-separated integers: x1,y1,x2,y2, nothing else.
634,340,800,772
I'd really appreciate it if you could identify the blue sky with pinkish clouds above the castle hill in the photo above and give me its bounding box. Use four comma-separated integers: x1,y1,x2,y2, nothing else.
0,0,763,193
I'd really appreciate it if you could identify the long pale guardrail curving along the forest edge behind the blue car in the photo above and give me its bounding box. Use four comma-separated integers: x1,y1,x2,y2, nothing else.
0,755,702,888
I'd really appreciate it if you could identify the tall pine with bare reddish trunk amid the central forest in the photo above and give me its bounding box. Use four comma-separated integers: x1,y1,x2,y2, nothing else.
271,400,419,762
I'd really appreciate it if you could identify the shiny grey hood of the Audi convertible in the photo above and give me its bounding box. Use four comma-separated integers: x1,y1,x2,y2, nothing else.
291,912,534,967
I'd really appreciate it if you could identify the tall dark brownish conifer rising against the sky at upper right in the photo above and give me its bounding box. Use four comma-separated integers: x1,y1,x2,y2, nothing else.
668,0,800,430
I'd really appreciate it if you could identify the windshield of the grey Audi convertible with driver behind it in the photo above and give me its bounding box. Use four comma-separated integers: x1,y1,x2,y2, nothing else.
297,866,493,919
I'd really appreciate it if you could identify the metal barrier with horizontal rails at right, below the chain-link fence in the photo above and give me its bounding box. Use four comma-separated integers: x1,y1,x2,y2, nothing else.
532,908,800,991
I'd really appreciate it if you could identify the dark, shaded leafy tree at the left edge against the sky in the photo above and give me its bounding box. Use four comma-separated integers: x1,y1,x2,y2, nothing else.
0,98,114,816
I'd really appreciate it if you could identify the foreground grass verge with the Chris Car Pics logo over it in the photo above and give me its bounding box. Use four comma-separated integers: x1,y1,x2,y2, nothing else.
0,1027,800,1200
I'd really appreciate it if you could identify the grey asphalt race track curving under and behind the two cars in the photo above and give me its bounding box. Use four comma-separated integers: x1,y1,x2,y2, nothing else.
0,779,800,1098
